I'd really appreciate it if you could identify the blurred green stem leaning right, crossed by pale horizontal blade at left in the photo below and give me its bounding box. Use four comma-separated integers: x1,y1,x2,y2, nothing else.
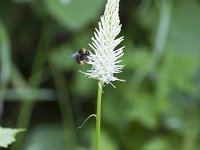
11,22,51,150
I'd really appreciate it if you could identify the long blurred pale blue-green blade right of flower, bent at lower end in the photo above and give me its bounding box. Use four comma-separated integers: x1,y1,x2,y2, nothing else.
130,0,172,88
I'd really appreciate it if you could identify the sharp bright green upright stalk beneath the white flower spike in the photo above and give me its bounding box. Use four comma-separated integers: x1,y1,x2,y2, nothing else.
96,81,103,150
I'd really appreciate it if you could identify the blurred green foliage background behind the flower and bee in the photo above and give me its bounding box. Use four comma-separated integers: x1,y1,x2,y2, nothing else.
0,0,200,150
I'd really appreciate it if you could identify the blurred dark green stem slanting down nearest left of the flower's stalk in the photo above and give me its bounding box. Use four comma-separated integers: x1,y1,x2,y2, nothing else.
49,62,77,149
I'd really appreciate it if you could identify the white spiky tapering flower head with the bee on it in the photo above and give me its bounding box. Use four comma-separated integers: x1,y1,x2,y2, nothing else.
84,0,124,86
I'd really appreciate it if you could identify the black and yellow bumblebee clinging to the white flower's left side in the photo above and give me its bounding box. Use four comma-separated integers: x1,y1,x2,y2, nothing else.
71,48,90,65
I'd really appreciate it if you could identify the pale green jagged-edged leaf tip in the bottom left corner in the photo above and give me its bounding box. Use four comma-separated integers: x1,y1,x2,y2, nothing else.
0,127,24,148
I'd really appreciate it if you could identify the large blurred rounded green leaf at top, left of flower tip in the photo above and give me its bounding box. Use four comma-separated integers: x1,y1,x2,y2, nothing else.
44,0,105,30
